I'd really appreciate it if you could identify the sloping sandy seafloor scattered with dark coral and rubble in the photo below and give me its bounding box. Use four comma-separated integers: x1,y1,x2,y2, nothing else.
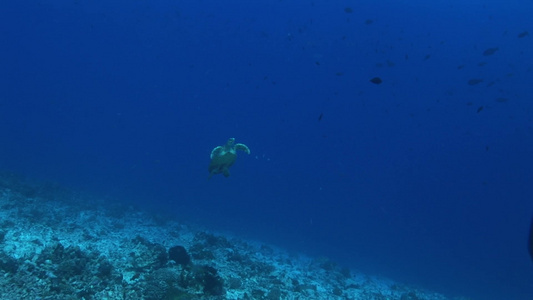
0,175,464,300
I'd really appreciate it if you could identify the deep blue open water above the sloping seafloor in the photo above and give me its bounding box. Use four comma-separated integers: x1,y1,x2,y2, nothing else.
0,0,533,299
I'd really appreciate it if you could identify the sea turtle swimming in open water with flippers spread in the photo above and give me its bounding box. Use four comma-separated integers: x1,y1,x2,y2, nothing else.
209,138,250,178
